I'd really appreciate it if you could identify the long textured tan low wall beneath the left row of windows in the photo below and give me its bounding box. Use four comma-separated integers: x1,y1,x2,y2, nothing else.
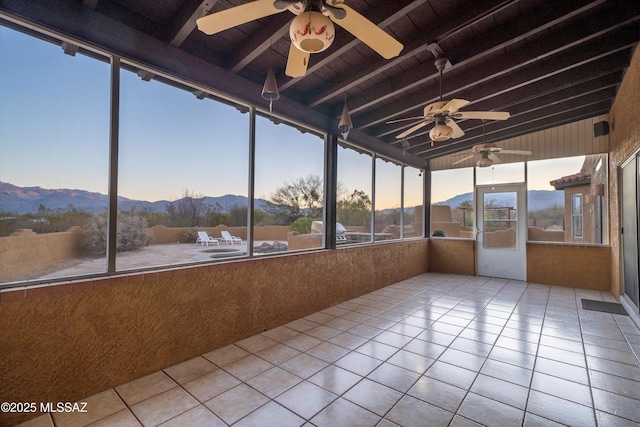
0,239,429,425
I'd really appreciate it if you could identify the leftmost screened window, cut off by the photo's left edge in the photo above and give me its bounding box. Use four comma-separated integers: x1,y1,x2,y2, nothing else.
0,27,110,282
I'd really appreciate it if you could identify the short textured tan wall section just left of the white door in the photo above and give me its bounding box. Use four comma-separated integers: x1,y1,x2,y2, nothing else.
429,238,476,276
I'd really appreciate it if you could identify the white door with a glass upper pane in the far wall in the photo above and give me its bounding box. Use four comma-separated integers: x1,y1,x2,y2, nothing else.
476,184,527,280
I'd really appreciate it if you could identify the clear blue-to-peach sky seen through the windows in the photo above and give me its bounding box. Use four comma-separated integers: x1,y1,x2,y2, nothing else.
0,23,582,209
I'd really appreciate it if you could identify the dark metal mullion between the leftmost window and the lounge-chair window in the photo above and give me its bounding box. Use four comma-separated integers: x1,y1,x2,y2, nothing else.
107,56,120,273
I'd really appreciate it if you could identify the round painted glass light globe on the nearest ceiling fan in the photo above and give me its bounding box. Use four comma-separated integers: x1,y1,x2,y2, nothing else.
289,10,336,53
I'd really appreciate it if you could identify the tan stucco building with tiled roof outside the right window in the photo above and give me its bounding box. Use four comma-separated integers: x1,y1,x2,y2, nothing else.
549,155,607,243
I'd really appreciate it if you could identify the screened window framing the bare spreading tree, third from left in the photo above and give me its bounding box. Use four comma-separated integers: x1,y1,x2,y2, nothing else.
254,115,324,255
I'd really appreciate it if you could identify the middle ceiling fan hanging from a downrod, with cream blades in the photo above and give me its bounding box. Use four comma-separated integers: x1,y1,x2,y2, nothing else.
387,57,509,145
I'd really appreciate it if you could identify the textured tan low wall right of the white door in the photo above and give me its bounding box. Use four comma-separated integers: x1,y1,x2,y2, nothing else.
527,243,611,291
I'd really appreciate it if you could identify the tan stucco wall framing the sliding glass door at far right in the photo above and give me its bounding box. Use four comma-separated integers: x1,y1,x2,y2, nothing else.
608,43,640,297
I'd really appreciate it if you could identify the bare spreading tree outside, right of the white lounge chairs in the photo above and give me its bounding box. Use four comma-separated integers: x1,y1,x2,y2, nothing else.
266,175,324,225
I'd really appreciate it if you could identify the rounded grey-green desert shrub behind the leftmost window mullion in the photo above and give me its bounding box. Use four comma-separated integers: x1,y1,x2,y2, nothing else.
85,212,153,254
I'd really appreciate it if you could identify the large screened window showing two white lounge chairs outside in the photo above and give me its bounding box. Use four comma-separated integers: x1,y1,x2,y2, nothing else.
116,68,250,270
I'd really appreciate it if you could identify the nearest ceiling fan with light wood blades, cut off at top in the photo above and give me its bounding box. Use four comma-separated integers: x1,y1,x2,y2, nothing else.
196,0,404,77
